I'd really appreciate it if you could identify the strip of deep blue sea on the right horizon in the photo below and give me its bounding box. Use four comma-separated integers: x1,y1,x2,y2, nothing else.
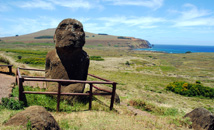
135,45,214,53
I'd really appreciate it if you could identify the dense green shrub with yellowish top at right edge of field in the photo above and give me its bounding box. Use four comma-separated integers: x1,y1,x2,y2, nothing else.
165,81,214,98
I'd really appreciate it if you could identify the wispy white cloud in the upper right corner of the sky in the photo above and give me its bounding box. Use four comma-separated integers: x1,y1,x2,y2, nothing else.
174,4,214,27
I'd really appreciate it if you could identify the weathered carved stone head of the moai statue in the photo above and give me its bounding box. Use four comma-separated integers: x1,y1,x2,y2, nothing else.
54,19,85,49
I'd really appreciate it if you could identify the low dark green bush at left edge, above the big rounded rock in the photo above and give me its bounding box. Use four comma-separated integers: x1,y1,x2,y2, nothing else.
1,98,24,110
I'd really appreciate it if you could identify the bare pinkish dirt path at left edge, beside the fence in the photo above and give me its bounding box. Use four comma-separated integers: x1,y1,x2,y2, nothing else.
0,73,15,102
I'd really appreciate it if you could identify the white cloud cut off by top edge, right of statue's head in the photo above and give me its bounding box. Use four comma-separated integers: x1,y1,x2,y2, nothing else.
105,0,164,9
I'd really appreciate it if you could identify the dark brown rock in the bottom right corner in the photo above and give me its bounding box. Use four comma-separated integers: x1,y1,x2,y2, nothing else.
184,108,214,130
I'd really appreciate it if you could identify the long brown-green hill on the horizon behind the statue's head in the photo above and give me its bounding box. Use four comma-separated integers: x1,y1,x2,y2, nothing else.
1,28,150,49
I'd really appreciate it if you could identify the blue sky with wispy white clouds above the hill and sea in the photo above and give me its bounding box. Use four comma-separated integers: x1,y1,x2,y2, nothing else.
0,0,214,46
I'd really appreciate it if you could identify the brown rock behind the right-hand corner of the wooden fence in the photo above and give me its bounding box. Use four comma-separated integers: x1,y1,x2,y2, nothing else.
93,86,120,103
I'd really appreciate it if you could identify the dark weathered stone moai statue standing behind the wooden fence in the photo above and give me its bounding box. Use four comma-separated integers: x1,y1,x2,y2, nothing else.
45,19,89,101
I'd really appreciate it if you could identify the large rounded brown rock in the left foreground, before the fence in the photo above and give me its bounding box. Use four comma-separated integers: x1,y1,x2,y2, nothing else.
4,106,60,130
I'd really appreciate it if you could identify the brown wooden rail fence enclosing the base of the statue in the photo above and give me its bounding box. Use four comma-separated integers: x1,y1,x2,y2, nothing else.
16,68,117,111
